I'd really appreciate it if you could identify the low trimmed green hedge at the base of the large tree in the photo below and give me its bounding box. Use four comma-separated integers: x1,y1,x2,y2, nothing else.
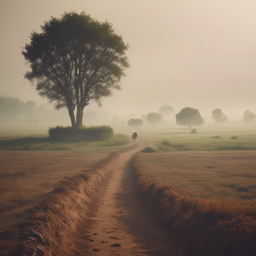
49,125,114,142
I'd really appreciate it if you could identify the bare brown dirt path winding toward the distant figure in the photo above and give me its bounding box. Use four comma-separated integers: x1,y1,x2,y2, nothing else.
83,142,181,256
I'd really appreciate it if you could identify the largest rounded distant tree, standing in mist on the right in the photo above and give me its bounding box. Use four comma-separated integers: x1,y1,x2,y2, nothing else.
176,107,204,129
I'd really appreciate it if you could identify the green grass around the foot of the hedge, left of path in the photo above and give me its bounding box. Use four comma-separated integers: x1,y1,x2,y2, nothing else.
0,125,130,153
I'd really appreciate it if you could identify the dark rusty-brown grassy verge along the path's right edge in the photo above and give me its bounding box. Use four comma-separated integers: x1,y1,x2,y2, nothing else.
132,155,256,256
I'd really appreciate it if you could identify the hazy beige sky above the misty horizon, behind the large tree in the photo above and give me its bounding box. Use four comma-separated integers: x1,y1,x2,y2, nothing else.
0,0,256,120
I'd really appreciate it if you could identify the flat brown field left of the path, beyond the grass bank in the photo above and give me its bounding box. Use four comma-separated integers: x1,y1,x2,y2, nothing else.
0,152,108,230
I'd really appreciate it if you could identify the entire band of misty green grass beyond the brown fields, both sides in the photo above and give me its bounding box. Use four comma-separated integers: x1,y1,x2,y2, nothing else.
0,122,256,152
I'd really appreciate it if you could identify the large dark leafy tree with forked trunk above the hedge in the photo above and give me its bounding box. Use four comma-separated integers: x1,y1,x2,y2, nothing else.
22,12,129,127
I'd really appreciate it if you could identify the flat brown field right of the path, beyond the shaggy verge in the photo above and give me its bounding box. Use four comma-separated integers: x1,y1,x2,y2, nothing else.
135,151,256,204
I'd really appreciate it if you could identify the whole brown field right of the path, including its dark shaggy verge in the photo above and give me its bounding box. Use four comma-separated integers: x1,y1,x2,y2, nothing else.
133,152,256,256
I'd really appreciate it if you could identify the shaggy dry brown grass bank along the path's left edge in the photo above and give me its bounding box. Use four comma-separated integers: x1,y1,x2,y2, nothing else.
0,153,119,256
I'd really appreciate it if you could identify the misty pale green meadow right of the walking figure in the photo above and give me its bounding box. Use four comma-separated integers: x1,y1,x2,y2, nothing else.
115,122,256,152
